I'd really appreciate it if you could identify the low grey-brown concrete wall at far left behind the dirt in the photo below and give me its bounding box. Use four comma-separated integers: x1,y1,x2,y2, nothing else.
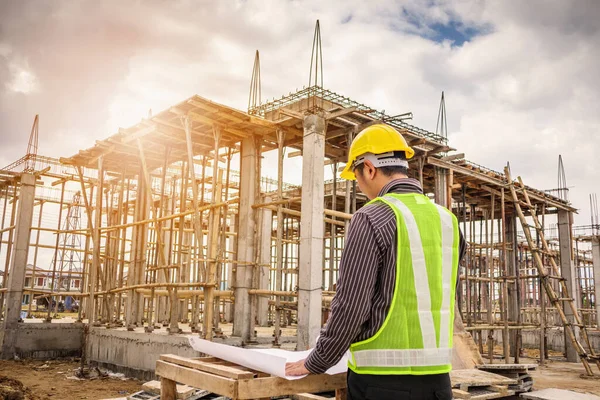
0,323,83,359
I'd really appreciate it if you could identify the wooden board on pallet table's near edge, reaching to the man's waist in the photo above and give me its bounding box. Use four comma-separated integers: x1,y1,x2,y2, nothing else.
237,373,346,399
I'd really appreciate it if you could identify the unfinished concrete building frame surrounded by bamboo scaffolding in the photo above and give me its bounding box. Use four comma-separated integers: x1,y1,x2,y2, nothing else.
0,23,600,390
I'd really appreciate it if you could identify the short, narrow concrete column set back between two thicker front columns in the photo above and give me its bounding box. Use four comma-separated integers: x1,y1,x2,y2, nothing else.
256,197,279,326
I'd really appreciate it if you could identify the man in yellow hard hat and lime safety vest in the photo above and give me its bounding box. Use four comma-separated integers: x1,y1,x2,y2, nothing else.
286,124,464,400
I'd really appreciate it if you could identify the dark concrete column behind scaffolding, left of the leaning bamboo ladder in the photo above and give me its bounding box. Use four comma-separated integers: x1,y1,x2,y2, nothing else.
505,215,521,357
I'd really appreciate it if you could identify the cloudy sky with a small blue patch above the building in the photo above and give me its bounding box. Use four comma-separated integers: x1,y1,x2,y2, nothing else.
0,0,600,231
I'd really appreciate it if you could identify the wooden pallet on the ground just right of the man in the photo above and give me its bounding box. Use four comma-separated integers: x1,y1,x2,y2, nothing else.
450,369,517,400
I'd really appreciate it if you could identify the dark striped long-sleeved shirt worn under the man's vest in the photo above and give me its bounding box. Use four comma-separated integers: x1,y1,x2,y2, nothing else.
305,178,464,374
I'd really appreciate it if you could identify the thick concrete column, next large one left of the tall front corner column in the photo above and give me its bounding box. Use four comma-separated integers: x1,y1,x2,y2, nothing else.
233,137,259,342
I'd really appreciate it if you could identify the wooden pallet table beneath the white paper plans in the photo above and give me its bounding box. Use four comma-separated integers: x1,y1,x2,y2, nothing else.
156,354,346,400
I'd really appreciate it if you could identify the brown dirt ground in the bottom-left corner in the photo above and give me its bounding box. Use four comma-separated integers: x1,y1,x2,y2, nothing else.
0,360,142,400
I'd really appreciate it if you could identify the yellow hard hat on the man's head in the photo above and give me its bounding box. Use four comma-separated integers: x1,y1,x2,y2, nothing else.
341,124,415,181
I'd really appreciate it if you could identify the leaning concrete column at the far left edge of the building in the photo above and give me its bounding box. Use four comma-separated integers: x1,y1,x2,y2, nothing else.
1,174,35,359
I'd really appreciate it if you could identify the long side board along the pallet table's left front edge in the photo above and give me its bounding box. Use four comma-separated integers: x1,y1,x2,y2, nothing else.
155,360,237,400
